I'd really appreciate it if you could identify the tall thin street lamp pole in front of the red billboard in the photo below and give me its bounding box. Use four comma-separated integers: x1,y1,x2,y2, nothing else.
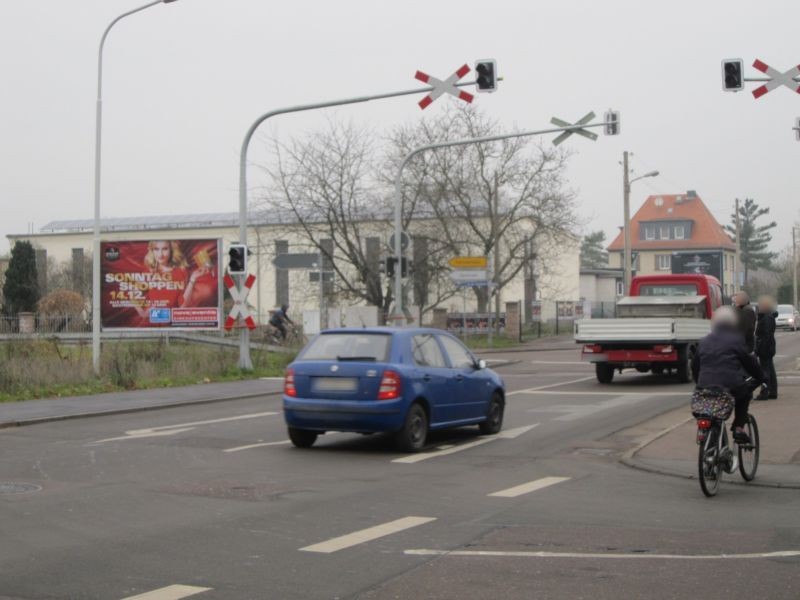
92,0,176,375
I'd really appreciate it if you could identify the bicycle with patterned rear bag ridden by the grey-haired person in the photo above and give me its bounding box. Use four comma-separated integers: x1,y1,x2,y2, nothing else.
692,380,760,498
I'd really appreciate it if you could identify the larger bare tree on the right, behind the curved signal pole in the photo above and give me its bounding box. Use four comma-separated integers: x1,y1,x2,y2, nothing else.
385,105,578,311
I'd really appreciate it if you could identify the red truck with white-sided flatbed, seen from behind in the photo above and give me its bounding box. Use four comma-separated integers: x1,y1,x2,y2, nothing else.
575,274,722,383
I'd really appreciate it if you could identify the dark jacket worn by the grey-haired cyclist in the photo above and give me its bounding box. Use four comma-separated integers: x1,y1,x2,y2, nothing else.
692,326,764,392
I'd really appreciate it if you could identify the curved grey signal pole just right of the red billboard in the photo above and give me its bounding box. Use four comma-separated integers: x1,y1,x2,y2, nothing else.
237,78,488,370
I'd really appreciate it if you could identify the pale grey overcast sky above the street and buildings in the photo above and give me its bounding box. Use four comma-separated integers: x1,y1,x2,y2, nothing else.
0,0,800,253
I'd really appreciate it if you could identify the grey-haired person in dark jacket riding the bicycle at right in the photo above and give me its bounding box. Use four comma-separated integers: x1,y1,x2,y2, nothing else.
692,306,764,444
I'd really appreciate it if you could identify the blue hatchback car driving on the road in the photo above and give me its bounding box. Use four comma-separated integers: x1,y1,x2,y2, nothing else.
283,327,505,452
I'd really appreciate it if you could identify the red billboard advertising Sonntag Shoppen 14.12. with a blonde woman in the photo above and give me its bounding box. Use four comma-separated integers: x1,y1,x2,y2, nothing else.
100,239,222,330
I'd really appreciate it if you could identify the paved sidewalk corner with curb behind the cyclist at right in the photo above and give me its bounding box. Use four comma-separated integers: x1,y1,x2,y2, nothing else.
623,378,800,489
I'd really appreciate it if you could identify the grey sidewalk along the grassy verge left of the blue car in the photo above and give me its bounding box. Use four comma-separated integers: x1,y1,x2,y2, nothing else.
0,379,283,428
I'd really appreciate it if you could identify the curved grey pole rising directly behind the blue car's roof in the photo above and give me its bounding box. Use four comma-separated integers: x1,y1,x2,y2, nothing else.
391,122,605,326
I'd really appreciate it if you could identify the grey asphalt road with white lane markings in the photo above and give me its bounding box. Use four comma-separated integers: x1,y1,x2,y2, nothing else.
0,333,800,600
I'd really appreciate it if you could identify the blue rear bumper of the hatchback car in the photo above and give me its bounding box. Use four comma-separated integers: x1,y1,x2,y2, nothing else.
283,396,405,433
